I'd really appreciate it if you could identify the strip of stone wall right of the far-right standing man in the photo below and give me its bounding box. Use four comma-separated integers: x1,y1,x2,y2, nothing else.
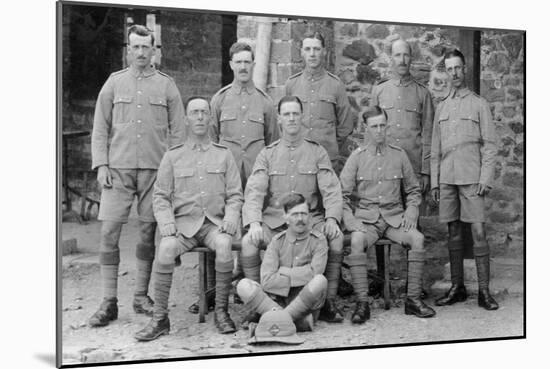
480,31,525,258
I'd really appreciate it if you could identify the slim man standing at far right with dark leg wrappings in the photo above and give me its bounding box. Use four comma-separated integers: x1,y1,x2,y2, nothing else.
431,50,498,310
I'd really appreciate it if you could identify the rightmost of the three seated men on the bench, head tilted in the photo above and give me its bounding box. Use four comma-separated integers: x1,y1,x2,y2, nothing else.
340,105,435,323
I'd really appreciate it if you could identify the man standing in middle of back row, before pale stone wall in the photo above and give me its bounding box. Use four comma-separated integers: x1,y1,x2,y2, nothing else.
285,32,353,174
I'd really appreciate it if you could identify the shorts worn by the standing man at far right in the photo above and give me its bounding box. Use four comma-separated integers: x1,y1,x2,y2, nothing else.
439,183,485,223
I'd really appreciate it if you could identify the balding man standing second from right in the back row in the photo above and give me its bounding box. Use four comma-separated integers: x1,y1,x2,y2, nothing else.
371,39,433,194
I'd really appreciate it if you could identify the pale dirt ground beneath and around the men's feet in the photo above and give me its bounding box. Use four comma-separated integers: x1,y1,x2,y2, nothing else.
62,221,524,364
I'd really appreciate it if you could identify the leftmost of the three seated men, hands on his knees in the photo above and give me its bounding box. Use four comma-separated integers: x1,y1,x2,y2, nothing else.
135,97,243,341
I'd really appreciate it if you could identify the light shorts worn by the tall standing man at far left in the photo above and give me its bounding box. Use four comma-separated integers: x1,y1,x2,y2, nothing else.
98,168,157,223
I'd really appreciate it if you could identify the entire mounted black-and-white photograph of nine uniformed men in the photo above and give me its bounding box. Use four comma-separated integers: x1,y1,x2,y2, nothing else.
52,0,542,367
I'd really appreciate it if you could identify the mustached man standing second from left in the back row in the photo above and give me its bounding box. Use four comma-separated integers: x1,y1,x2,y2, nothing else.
210,42,279,188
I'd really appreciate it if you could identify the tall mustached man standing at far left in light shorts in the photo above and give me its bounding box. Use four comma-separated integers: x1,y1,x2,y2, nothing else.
89,25,183,327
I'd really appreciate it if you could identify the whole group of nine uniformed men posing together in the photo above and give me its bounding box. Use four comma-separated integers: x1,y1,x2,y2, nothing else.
89,25,498,341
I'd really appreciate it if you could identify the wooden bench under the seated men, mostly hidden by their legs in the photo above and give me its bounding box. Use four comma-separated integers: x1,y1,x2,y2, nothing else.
192,234,395,323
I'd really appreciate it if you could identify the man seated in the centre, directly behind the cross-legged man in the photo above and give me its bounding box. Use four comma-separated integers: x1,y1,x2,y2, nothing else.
241,96,343,322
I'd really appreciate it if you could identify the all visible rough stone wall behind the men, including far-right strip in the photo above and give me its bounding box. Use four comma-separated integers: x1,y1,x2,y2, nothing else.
237,16,524,281
